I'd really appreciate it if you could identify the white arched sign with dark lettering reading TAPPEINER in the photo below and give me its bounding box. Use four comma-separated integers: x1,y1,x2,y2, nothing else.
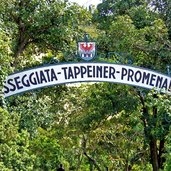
4,62,171,97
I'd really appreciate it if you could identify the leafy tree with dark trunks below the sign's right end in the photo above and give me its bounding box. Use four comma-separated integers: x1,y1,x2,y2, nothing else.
139,92,170,171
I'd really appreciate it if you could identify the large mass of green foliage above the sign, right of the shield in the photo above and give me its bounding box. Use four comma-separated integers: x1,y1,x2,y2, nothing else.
94,0,171,70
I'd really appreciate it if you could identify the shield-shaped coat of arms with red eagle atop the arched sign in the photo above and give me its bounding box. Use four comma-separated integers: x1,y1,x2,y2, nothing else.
78,33,96,61
